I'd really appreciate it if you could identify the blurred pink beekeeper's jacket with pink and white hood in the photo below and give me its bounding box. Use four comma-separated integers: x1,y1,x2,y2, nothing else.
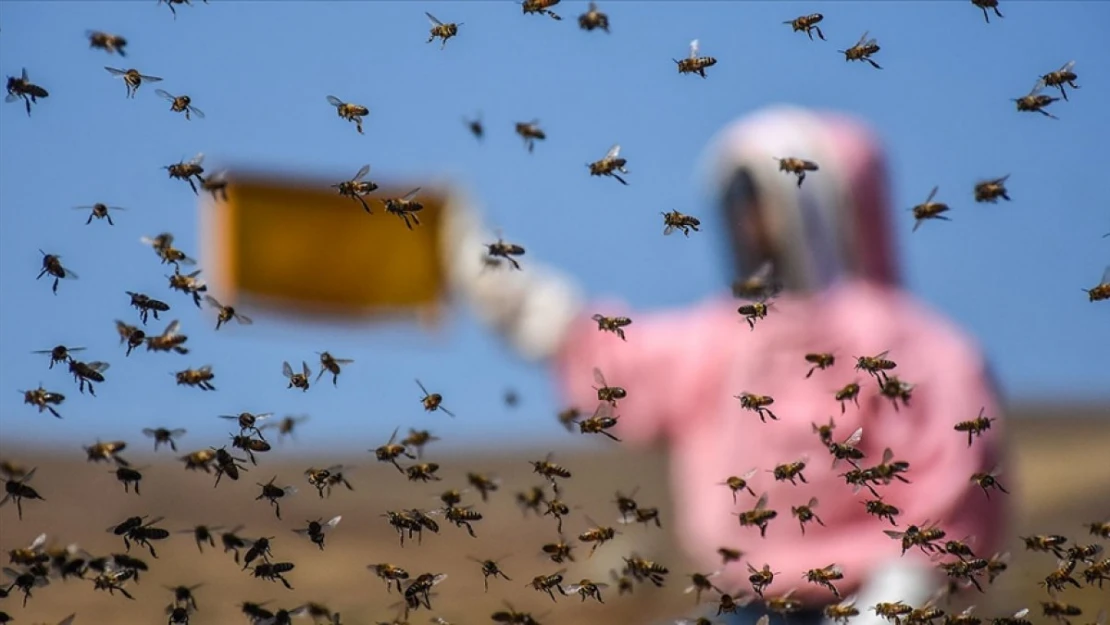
555,108,1006,606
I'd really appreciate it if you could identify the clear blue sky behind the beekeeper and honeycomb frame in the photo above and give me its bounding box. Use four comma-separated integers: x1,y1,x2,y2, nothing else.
0,0,1110,450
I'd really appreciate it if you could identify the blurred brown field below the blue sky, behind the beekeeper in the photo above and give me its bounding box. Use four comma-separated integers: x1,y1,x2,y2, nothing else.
0,406,1110,625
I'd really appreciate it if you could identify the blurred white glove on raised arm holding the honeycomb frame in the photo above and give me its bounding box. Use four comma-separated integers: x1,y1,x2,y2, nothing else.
440,194,583,360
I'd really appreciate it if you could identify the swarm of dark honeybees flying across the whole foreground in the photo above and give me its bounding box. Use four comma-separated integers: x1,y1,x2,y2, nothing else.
0,0,1110,625
